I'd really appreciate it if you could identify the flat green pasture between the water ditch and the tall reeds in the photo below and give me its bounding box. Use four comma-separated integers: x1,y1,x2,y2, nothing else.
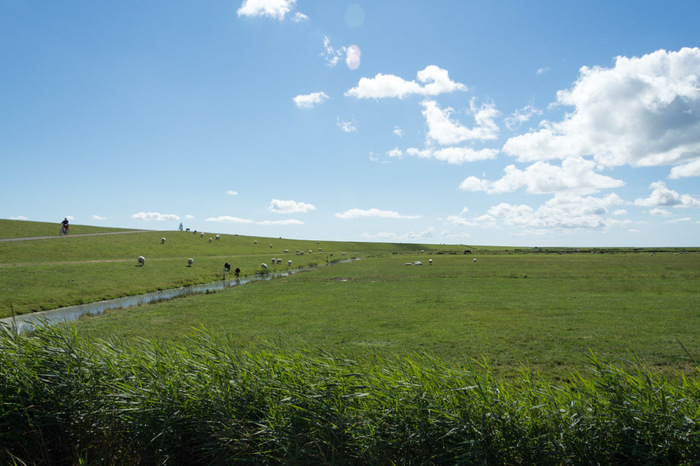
77,248,700,377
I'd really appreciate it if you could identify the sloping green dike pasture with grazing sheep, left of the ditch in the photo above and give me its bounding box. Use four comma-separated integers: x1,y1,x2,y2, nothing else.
0,220,459,318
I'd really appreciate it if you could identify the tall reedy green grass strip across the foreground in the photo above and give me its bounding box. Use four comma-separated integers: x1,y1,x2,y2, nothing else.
0,328,700,464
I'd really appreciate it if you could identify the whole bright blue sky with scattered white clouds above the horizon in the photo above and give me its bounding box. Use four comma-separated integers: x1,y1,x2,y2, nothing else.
0,0,700,247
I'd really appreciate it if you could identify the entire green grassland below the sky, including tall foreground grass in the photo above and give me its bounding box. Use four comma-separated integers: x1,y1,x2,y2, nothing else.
0,220,700,464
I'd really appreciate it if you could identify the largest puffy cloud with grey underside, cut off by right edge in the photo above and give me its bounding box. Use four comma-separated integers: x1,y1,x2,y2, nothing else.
503,48,700,173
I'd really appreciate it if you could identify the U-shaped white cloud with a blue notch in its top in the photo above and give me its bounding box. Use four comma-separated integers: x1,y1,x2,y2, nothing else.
421,99,498,145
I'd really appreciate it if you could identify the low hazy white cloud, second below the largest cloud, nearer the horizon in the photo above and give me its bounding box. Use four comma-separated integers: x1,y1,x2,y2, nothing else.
488,194,623,233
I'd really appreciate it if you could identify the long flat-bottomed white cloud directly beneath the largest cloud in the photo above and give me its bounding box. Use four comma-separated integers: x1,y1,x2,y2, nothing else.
459,157,624,194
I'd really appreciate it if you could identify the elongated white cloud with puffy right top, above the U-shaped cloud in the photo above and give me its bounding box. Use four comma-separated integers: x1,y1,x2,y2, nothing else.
345,65,467,99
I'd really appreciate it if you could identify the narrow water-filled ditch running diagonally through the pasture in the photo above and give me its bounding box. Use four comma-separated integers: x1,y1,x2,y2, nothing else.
0,259,359,333
